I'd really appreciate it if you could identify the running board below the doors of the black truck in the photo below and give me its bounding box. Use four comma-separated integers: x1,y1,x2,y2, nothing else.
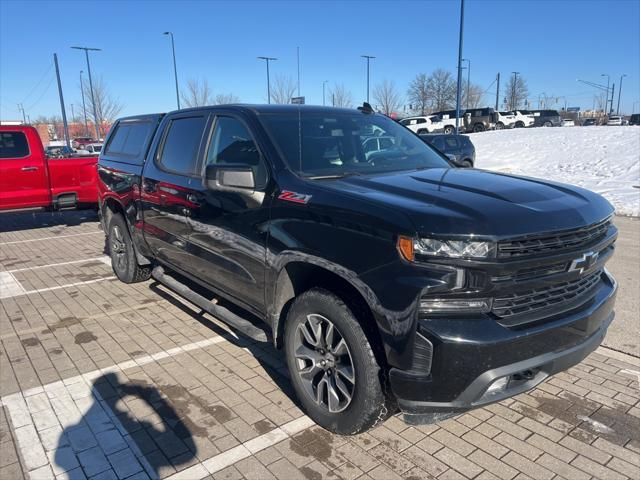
151,267,268,342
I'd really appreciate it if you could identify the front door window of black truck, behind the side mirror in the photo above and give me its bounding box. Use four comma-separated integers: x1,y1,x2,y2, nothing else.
206,116,267,187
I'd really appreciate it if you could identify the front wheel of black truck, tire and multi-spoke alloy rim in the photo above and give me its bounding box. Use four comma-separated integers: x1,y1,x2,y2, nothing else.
284,289,392,435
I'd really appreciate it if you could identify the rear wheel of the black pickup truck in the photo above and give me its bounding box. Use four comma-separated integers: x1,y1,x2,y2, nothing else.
108,213,151,283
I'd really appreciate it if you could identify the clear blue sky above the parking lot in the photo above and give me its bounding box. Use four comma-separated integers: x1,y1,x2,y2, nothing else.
0,0,640,120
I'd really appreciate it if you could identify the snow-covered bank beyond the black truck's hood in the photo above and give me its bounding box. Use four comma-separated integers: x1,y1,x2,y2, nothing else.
470,126,640,216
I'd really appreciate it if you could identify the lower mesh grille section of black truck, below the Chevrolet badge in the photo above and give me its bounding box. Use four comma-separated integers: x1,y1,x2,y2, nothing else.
492,270,602,320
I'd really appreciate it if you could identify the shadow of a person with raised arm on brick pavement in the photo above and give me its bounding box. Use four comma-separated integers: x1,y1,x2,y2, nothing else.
52,373,197,480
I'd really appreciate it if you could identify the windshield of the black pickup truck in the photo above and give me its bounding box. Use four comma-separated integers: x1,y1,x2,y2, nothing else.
261,111,450,177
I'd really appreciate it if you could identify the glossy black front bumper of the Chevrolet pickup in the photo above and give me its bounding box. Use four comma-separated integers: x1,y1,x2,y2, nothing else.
389,271,617,424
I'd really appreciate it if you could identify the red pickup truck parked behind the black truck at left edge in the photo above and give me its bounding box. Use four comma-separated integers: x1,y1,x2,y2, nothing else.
0,125,98,210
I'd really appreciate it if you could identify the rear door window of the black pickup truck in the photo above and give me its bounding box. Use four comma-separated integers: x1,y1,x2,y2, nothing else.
160,116,207,175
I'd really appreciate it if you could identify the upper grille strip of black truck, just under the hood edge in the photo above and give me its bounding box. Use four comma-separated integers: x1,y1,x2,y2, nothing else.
498,218,611,258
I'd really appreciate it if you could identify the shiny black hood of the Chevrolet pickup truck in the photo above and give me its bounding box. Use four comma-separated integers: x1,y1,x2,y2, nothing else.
316,168,613,240
